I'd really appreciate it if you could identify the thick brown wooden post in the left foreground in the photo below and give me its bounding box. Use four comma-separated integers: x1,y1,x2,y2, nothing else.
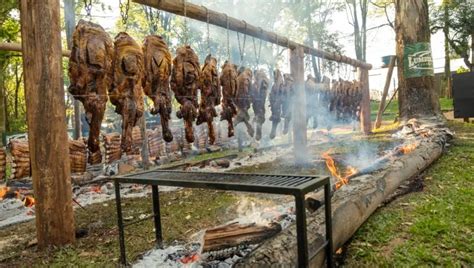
20,0,75,248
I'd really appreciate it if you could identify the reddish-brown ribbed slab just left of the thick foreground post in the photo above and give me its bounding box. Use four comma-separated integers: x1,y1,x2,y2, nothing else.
9,140,31,179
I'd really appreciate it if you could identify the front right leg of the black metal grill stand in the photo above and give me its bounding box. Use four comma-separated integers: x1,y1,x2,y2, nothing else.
295,194,309,267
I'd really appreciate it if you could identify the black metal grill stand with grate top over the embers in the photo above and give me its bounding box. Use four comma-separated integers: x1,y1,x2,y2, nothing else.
113,170,333,267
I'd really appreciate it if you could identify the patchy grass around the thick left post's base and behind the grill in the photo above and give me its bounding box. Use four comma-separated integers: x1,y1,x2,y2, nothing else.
0,190,237,267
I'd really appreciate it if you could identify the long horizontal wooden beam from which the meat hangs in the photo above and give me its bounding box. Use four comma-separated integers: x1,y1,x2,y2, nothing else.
133,0,372,70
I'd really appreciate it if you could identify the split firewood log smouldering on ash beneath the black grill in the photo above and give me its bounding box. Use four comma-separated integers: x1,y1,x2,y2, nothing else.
202,222,281,252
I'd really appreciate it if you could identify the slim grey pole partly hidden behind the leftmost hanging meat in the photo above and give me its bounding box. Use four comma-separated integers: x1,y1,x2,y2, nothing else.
64,0,81,140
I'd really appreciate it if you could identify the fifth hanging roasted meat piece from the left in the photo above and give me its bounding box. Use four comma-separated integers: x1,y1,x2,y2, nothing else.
196,54,221,144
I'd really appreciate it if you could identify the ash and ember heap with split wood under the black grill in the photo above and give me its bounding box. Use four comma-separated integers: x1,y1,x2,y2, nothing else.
133,199,295,267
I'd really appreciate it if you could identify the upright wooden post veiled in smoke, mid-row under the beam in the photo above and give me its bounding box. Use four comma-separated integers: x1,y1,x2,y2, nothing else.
289,46,307,164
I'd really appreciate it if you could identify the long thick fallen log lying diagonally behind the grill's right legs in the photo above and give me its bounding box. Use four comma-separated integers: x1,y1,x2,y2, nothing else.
236,123,450,267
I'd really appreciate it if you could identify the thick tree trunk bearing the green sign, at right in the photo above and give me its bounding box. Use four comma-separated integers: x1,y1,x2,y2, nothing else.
395,0,440,120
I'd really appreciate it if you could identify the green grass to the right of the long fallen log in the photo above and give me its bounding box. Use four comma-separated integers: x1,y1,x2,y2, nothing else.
345,122,474,267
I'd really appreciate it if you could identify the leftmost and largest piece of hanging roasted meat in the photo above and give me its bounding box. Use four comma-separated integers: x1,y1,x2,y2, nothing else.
68,20,113,164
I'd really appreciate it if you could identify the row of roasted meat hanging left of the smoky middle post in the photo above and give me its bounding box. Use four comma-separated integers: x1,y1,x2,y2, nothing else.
69,20,362,164
